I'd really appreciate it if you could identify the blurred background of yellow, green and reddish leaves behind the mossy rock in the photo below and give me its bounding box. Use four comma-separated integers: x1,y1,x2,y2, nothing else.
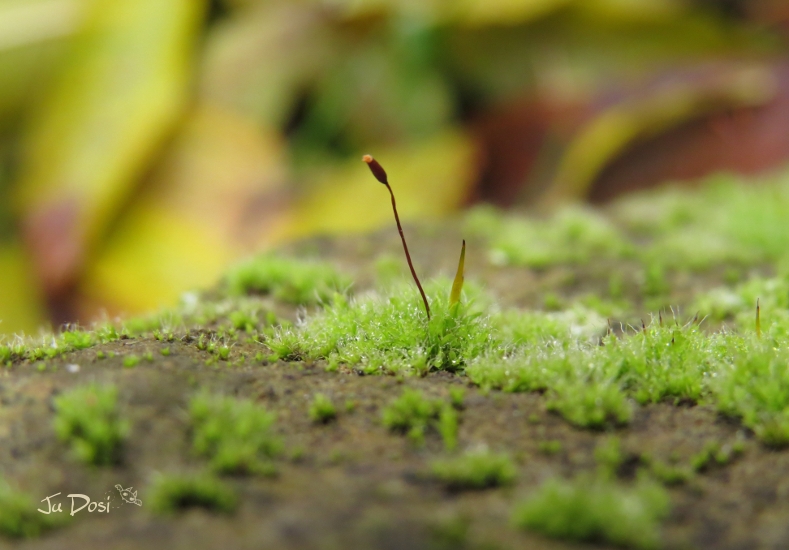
0,0,789,333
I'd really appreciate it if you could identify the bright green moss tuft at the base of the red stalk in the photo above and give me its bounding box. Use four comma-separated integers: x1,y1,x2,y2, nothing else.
266,279,491,373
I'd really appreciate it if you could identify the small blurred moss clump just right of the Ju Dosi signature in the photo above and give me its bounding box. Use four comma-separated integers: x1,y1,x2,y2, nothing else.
149,474,238,515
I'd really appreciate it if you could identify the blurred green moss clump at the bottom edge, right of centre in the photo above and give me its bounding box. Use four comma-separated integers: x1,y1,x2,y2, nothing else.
513,476,669,550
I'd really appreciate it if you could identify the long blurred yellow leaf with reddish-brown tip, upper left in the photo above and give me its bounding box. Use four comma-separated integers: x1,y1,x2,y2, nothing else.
15,0,205,288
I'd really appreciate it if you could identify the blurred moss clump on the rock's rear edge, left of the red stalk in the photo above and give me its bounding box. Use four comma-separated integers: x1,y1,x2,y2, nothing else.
225,254,344,306
